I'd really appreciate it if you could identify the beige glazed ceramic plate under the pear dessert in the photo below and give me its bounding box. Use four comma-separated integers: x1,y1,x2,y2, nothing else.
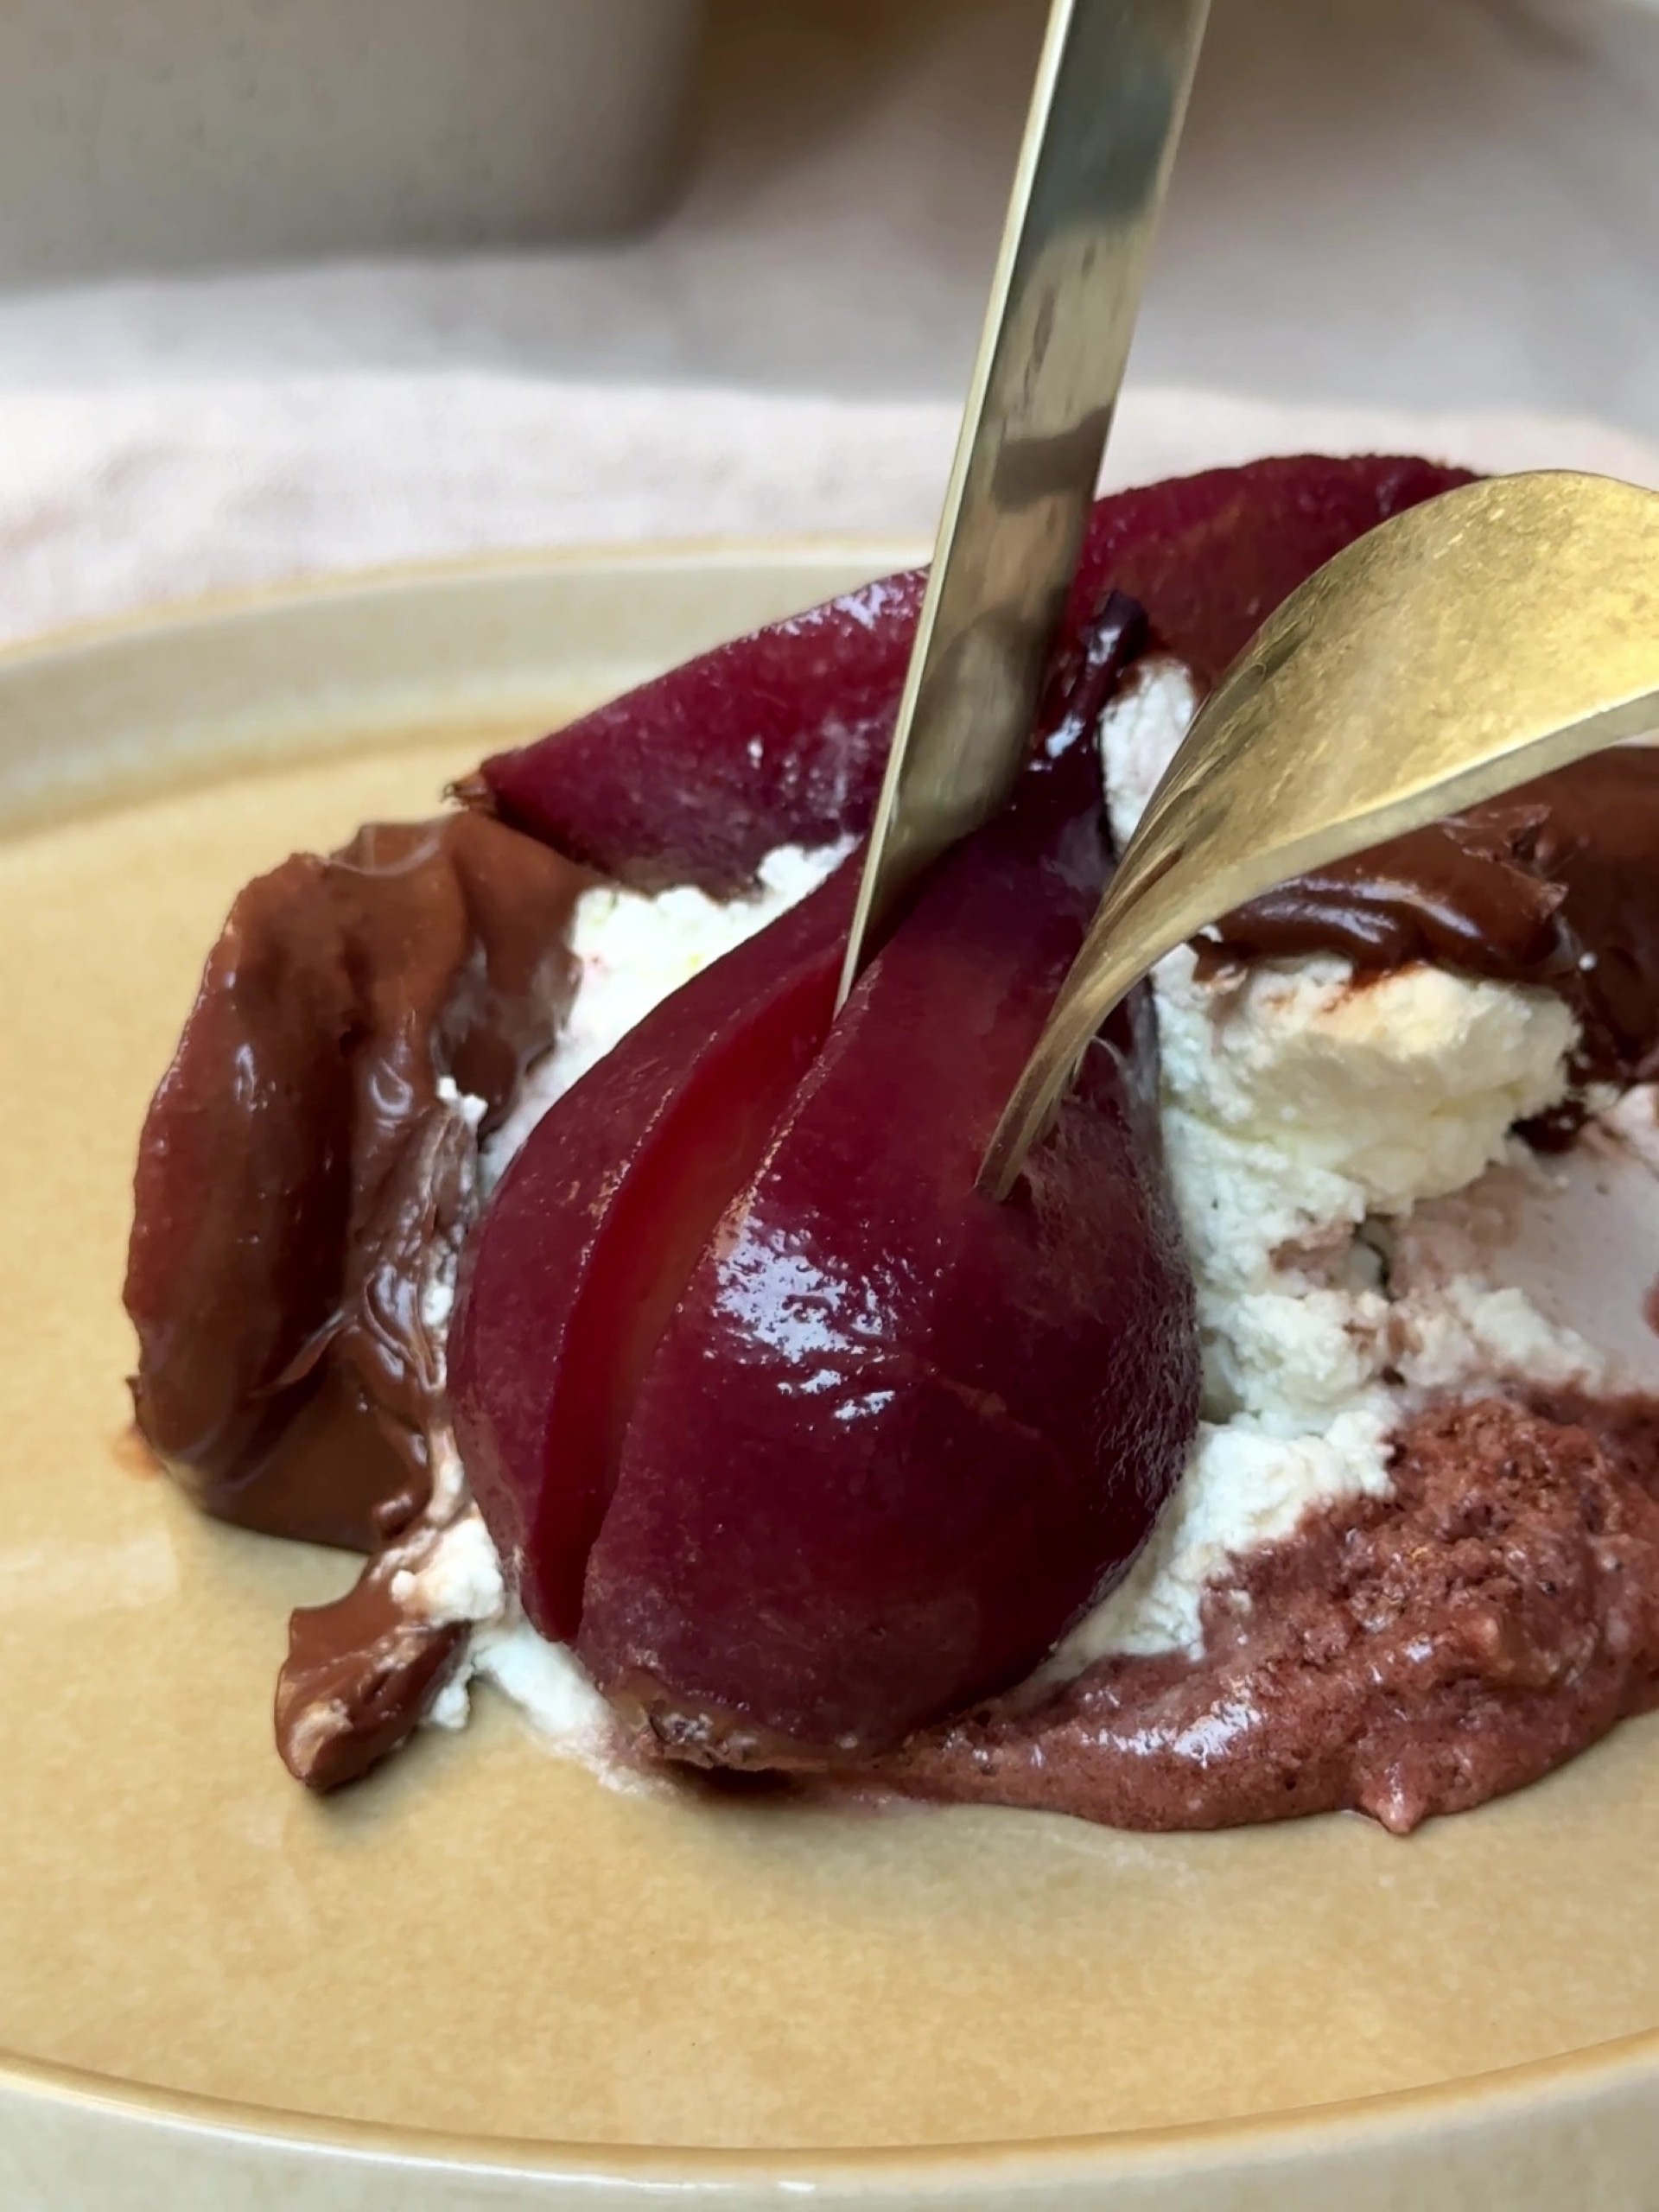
0,546,1659,2212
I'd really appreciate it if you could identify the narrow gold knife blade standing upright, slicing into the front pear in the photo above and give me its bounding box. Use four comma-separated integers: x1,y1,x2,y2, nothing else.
841,0,1210,1000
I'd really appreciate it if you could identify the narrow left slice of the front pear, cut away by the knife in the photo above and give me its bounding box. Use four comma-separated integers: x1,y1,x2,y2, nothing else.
449,862,858,1639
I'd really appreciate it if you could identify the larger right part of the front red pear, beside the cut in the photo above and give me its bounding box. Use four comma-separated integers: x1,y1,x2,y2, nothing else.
577,743,1197,1765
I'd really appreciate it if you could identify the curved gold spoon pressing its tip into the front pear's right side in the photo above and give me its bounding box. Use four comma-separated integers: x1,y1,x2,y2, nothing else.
980,474,1659,1199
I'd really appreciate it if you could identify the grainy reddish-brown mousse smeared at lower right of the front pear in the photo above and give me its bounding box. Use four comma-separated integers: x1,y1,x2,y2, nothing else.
868,1398,1659,1834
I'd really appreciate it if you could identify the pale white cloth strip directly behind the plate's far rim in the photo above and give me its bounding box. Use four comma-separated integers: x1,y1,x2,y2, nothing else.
0,374,1659,639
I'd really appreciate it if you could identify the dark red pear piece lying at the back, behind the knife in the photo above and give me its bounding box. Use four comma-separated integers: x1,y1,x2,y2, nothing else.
469,455,1469,893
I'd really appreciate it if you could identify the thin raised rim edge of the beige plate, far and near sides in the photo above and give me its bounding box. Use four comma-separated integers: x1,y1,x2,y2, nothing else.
0,543,1659,2190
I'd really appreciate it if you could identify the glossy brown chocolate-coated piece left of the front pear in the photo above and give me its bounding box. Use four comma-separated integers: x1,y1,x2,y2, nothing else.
126,814,591,1551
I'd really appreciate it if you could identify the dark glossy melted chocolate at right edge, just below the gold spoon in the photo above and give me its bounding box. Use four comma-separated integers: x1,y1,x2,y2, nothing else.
1204,746,1659,1082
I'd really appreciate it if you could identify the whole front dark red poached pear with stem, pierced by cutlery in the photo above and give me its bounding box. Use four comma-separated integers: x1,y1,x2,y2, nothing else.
451,619,1197,1765
